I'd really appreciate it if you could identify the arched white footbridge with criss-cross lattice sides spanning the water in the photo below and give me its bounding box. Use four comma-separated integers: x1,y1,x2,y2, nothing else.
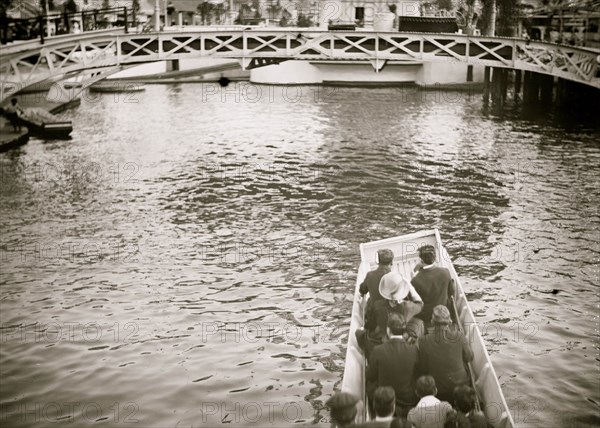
0,28,600,100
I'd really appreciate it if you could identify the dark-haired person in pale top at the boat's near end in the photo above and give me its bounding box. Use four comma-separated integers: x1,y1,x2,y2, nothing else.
407,376,453,428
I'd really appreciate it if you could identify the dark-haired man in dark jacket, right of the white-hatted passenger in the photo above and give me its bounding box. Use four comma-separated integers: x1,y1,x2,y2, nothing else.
411,245,454,327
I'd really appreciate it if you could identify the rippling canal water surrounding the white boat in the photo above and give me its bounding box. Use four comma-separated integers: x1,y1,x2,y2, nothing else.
0,83,600,427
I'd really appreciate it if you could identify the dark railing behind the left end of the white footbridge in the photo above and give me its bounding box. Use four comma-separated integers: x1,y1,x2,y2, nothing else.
0,7,127,44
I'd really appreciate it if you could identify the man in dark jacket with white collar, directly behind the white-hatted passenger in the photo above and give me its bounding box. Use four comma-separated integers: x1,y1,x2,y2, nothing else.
366,312,419,417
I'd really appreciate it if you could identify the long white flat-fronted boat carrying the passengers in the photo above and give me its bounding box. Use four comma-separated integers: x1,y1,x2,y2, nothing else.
341,229,514,428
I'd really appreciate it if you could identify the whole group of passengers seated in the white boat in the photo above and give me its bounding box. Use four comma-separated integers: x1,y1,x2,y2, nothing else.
329,245,487,428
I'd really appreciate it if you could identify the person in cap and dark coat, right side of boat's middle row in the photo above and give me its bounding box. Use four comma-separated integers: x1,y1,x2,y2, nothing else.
419,305,473,401
